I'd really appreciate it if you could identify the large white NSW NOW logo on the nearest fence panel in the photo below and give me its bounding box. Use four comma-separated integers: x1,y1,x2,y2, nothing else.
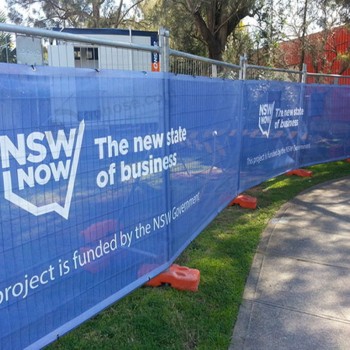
0,120,85,219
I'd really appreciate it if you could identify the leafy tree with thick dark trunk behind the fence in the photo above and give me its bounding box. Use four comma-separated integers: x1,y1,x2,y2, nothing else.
143,0,257,60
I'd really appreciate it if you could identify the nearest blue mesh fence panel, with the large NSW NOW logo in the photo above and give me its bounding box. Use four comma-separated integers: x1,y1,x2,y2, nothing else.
0,65,170,349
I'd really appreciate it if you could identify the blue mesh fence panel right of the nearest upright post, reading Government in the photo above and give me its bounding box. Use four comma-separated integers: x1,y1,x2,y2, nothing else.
169,76,241,258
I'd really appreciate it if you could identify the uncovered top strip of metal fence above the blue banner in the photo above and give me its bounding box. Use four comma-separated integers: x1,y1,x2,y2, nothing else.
0,23,350,85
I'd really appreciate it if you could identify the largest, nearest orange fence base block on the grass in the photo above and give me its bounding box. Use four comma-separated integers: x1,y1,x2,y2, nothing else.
146,264,200,292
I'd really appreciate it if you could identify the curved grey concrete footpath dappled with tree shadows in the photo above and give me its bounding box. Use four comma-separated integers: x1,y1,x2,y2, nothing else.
229,178,350,350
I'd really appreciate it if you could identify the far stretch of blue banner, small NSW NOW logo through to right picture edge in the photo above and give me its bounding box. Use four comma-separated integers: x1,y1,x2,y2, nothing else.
239,81,350,192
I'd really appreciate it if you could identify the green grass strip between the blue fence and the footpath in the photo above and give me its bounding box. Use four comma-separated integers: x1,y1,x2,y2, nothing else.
49,162,350,350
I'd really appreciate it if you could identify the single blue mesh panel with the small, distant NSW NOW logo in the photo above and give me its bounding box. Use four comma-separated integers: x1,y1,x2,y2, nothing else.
239,81,304,192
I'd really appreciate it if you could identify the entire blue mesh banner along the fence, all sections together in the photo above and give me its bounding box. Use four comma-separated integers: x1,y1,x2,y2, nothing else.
0,64,350,349
